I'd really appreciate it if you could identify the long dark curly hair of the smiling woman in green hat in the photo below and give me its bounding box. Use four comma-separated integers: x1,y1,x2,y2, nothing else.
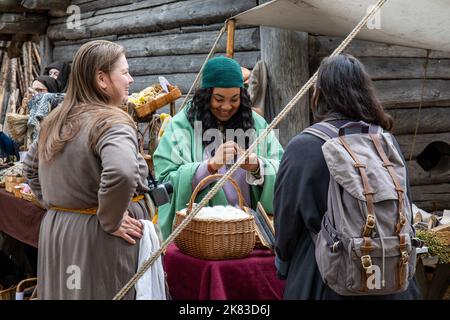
188,88,254,148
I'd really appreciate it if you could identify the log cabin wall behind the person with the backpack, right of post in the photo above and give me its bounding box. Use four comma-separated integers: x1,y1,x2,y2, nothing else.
309,35,450,211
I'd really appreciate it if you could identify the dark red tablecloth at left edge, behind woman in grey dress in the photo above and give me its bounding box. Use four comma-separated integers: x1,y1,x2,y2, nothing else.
0,188,45,248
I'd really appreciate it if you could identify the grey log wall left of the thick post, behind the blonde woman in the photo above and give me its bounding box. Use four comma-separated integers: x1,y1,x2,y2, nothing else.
47,0,260,109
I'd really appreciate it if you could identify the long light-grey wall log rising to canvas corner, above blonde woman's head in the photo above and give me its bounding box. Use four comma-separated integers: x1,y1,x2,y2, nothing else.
47,0,256,41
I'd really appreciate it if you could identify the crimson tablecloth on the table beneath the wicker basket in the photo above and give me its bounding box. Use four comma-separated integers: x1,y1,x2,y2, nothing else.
164,244,284,300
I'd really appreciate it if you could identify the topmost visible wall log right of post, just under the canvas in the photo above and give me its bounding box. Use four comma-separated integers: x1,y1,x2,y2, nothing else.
309,36,450,58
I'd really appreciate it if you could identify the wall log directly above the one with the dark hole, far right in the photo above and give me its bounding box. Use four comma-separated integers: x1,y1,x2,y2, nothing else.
387,107,450,134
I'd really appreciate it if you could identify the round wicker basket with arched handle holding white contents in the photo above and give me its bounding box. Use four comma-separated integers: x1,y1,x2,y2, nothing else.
174,174,256,260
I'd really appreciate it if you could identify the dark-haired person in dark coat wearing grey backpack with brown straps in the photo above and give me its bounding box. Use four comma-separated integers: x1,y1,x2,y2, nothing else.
274,54,421,299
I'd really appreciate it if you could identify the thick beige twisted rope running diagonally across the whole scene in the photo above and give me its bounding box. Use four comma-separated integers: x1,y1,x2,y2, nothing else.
114,0,387,300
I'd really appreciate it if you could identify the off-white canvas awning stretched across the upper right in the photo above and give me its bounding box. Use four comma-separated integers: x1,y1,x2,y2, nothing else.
232,0,450,52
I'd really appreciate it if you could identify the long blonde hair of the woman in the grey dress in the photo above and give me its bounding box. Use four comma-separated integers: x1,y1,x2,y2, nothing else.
39,40,135,161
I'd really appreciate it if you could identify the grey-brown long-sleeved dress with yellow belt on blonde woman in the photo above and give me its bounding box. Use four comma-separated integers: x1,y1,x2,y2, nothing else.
24,118,148,299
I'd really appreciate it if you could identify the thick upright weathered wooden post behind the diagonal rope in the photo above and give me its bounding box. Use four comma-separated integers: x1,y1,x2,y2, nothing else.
261,27,310,146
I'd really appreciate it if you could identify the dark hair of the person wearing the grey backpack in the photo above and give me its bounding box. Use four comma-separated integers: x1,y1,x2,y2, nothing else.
312,54,393,130
